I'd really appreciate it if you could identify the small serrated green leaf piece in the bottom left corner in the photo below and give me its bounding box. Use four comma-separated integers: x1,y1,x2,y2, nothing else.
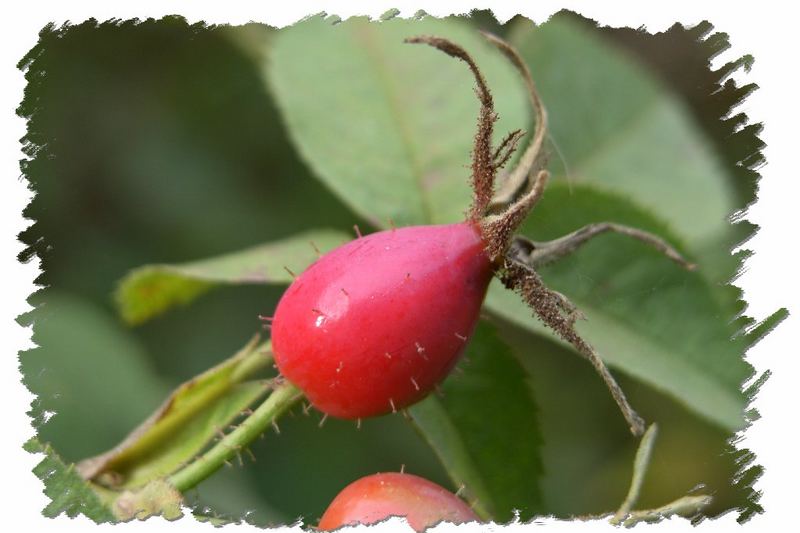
24,438,116,522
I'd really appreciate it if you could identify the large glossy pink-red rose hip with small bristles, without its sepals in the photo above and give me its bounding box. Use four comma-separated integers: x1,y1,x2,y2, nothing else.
272,223,492,419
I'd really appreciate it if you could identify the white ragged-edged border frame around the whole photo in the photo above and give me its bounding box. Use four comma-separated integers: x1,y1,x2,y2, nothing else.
0,0,800,532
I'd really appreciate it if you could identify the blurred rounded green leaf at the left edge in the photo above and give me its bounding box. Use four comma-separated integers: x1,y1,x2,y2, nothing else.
20,289,169,461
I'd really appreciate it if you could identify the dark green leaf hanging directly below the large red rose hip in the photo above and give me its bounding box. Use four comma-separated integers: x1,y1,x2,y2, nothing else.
408,323,542,521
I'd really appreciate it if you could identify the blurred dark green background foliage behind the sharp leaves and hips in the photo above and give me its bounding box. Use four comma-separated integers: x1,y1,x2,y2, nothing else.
20,12,761,525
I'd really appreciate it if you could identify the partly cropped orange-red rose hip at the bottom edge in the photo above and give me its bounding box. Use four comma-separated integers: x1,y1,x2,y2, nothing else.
318,472,479,531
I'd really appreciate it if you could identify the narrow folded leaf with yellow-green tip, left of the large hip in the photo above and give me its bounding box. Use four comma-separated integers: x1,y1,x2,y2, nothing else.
115,230,350,324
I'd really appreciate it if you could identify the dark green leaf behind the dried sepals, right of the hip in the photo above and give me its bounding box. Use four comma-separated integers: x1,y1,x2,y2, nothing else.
486,183,752,430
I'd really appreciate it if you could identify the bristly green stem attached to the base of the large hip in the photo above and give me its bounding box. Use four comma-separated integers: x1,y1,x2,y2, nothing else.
168,382,302,492
